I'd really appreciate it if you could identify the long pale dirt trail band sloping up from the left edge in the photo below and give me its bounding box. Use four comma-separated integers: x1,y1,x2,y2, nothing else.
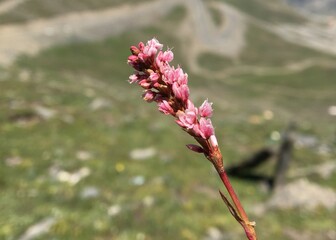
0,0,178,65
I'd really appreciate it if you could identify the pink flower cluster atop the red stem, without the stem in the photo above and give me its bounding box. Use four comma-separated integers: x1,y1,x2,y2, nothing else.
128,38,216,152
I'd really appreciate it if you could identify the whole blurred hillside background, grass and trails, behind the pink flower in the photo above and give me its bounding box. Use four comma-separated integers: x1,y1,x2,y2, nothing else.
0,0,336,240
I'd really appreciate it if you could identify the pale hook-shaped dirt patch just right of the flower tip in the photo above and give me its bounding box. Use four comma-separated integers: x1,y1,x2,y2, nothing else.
179,0,246,74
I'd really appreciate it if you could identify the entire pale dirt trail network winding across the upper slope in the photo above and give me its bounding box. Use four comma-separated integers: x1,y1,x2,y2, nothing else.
0,0,336,77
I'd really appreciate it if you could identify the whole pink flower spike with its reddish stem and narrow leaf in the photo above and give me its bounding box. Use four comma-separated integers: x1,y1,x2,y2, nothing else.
127,38,257,240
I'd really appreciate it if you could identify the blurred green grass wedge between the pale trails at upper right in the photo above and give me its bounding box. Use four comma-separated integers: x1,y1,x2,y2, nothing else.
199,24,336,71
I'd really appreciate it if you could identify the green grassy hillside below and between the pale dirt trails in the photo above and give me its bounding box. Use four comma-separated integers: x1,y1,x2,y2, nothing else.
0,1,336,240
